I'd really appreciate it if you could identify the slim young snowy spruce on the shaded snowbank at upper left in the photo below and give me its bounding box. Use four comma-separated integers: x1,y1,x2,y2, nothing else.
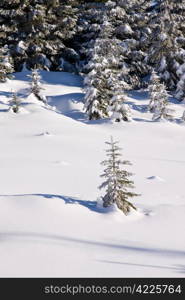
27,69,46,103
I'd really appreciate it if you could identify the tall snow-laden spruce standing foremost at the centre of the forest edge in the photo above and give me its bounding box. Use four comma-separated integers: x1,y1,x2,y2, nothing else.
84,17,129,120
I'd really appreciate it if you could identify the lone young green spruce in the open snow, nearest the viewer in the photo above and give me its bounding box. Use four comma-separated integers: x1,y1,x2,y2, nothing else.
99,137,139,215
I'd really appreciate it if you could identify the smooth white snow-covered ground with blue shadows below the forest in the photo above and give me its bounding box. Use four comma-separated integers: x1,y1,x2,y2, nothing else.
0,72,185,277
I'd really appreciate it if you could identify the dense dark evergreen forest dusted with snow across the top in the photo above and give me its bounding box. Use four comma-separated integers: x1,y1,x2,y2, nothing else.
0,0,185,119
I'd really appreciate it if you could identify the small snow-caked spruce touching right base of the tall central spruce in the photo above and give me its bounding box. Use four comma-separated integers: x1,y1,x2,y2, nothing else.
108,92,132,122
